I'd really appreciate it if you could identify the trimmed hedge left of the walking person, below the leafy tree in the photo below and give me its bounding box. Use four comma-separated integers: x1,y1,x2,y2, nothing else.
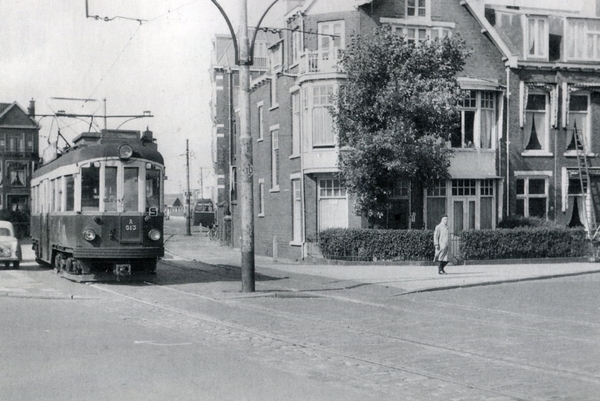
318,228,434,261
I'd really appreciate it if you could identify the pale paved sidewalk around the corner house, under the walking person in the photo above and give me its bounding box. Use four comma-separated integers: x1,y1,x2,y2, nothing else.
165,227,600,295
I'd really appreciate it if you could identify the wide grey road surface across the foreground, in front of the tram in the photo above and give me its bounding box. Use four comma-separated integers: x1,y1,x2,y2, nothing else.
0,228,600,401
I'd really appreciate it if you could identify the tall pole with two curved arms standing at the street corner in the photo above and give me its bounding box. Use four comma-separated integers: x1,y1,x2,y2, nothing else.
211,0,278,292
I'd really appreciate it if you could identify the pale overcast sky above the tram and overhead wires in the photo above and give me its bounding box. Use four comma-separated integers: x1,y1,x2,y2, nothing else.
0,0,594,193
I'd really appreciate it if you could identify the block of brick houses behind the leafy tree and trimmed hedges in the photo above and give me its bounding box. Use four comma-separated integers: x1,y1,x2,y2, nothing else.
211,0,600,259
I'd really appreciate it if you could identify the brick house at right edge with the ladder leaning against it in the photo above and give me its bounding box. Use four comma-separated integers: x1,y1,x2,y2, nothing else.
466,0,600,229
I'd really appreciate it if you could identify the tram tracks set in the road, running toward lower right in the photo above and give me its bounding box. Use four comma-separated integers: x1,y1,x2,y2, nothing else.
84,263,600,399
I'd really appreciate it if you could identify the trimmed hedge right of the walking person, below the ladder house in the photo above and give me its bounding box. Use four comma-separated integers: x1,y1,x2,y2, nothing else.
460,227,588,260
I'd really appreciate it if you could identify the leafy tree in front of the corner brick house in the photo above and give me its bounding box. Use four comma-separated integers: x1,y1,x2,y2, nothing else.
331,27,468,216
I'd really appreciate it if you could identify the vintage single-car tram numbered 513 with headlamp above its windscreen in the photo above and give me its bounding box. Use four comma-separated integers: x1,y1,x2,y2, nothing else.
31,130,164,282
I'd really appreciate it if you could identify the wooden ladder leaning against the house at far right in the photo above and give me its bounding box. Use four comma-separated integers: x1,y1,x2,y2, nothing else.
573,126,600,241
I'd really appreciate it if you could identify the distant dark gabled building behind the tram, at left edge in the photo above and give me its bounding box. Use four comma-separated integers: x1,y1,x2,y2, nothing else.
0,101,39,211
